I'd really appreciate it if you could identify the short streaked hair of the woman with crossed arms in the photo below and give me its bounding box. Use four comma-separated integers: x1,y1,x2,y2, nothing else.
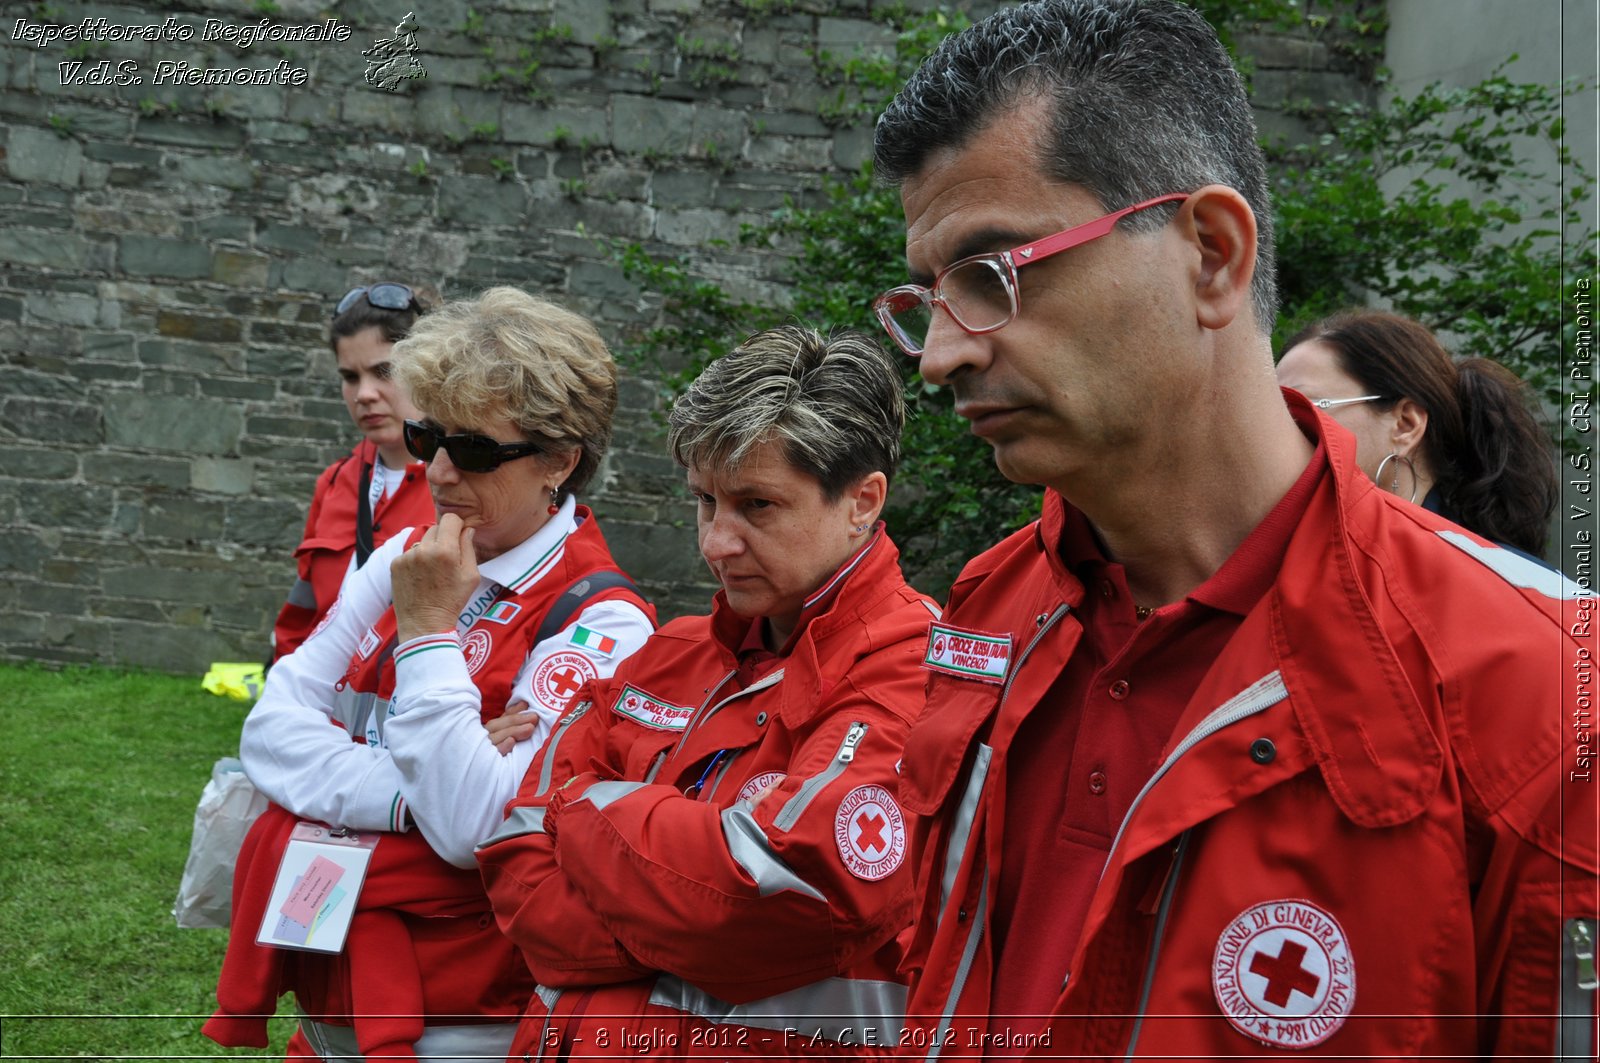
667,325,906,499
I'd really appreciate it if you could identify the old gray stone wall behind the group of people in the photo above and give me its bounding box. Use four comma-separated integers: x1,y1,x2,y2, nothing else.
0,0,1360,671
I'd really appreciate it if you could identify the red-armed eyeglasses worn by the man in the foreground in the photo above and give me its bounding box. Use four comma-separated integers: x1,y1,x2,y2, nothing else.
872,192,1189,357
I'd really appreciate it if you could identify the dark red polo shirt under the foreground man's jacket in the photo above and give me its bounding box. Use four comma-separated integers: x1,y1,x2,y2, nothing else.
990,445,1328,1033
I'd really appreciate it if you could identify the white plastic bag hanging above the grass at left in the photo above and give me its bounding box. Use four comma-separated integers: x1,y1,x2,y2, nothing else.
173,757,267,929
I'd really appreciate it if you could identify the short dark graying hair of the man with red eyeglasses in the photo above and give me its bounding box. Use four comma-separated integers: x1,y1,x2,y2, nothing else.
875,0,1278,333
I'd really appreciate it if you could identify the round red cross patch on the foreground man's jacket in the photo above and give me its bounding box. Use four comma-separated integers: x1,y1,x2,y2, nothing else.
1211,900,1355,1049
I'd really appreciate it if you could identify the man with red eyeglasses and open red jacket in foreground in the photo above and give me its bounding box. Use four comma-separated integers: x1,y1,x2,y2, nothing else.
875,0,1600,1060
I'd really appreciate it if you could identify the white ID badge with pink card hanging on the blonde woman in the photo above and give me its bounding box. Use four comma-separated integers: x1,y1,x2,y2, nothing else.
256,821,378,953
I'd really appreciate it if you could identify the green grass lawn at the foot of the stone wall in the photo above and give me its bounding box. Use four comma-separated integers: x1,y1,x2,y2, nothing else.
0,664,290,1060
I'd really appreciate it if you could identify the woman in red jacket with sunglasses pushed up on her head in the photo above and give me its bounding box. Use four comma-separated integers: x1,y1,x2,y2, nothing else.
272,280,434,661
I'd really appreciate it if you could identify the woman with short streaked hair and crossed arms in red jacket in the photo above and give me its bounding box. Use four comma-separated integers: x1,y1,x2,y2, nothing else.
478,325,947,1058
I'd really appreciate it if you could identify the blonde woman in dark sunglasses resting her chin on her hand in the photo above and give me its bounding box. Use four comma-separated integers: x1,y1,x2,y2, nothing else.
205,288,654,1063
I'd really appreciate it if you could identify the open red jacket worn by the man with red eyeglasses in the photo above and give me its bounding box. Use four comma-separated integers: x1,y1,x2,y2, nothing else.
901,395,1600,1060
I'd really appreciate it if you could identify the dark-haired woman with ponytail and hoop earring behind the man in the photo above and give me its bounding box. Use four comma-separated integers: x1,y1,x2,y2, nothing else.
1278,309,1558,564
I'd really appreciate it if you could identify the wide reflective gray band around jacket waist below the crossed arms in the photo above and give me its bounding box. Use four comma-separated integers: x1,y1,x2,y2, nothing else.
650,975,906,1045
